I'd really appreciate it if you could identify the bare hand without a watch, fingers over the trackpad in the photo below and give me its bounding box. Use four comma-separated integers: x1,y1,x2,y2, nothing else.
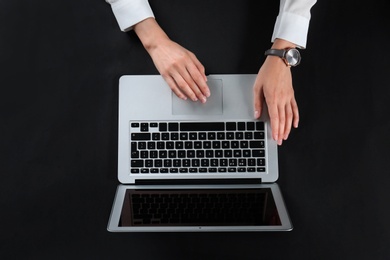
134,18,210,103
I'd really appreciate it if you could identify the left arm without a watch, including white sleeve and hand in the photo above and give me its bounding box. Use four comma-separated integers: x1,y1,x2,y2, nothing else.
106,0,210,103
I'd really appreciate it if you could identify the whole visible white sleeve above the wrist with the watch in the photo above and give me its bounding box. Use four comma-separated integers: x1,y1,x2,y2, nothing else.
271,0,316,48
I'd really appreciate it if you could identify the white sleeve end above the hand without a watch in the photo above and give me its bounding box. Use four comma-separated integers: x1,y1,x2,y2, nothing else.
106,0,154,32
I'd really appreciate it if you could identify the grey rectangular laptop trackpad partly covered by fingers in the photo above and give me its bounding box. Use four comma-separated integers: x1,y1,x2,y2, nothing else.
172,79,223,115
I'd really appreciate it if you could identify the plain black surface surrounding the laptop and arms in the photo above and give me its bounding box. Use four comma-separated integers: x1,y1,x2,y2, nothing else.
0,0,390,259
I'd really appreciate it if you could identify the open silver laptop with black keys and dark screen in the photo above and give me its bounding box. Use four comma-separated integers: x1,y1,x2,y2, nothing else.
107,74,293,232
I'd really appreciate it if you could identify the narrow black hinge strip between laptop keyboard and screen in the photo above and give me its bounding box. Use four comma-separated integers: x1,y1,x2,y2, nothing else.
135,178,261,185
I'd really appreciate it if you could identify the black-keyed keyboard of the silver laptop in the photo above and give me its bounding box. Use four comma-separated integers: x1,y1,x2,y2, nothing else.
130,121,266,174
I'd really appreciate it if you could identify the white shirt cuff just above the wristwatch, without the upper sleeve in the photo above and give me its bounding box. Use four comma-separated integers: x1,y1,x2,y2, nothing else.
271,12,310,49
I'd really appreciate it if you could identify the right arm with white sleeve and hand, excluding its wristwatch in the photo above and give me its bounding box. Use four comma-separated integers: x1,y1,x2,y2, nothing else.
253,0,315,145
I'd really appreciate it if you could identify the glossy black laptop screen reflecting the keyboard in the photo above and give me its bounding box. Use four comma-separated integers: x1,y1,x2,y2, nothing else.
119,188,281,227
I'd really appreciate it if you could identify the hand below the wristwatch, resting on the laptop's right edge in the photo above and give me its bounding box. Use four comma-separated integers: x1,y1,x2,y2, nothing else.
253,56,299,145
